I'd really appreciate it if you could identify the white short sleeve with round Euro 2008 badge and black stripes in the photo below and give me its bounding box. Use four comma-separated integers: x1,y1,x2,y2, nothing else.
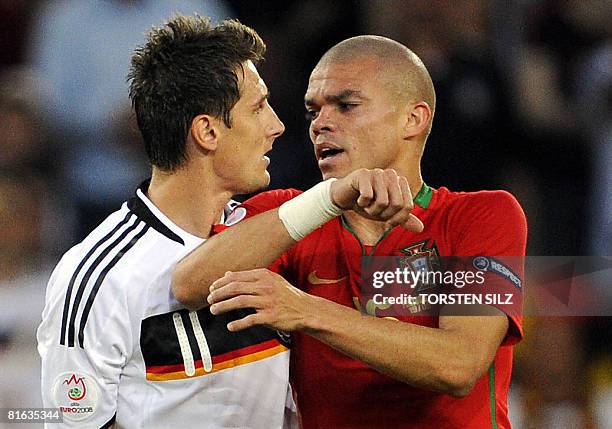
37,249,132,428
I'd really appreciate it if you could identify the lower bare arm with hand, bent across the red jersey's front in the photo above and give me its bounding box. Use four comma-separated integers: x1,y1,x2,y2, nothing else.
208,269,508,397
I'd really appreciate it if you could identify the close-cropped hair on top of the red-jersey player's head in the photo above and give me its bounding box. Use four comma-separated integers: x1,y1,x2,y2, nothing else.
313,35,436,127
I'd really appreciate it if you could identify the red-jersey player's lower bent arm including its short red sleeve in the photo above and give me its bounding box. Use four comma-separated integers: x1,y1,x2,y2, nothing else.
209,192,527,396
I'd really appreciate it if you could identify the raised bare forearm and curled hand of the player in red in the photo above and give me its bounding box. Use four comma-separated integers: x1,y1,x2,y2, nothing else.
172,169,423,309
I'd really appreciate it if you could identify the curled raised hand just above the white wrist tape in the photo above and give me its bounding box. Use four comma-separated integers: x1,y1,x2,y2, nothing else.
331,168,423,233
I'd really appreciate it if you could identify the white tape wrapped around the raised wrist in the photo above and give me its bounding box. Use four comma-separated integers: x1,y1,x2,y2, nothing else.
278,179,342,241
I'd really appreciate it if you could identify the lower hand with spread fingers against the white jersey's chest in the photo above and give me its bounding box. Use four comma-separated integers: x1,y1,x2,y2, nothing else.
208,268,317,332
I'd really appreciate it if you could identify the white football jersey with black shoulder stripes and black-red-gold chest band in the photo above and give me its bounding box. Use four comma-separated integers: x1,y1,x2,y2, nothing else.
38,184,295,429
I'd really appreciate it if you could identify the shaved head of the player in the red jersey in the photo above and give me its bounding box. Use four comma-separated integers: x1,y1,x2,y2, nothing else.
304,36,436,179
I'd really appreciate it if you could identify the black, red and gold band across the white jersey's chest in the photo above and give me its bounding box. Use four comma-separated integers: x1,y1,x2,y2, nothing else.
140,308,289,381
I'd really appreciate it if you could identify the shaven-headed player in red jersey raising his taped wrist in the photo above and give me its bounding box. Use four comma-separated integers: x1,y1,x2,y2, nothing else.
173,36,527,428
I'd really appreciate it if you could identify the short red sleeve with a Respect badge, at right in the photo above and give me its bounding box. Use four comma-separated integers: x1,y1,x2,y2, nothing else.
449,191,527,344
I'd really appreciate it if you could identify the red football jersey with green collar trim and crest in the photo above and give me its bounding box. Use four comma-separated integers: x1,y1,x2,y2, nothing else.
234,185,527,429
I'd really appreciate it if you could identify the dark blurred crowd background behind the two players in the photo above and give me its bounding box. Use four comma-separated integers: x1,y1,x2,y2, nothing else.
0,0,612,428
